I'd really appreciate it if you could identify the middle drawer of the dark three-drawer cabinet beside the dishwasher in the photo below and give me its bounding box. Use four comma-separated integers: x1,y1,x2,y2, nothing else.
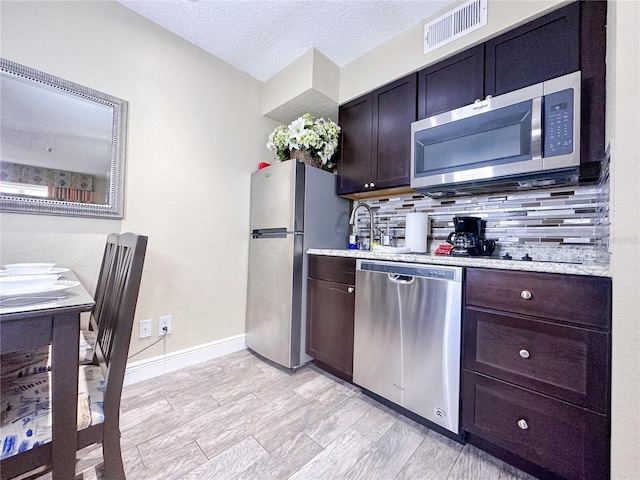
464,307,610,413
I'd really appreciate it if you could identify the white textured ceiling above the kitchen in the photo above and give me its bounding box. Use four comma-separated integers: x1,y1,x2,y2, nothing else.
120,0,458,81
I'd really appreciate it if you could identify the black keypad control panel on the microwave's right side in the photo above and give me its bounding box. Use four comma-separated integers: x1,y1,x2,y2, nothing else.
544,88,574,157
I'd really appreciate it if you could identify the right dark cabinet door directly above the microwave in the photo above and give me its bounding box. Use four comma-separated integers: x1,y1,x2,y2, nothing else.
485,2,581,96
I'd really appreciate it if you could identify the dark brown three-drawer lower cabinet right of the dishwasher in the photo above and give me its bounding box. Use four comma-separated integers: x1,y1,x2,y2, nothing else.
462,268,611,480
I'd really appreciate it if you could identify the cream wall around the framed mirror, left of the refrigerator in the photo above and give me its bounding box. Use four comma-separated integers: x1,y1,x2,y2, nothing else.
0,0,277,360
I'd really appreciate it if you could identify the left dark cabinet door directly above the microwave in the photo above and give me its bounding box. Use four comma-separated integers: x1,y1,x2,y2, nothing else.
418,44,484,120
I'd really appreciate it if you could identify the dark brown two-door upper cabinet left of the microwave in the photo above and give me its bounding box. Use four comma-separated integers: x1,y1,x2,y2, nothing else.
337,73,417,195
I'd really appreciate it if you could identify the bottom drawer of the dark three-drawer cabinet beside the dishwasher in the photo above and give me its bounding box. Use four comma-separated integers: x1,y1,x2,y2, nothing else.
462,370,609,480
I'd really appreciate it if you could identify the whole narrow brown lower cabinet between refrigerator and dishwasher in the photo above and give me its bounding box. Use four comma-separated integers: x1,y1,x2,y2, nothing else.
306,255,355,382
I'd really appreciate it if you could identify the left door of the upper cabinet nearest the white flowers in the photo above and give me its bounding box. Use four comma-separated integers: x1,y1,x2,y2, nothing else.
337,94,373,195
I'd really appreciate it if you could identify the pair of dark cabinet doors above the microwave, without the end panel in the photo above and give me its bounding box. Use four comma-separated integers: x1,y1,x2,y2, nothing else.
418,2,584,119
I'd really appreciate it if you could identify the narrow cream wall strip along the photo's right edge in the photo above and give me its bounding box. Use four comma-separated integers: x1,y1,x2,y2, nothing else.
607,0,640,480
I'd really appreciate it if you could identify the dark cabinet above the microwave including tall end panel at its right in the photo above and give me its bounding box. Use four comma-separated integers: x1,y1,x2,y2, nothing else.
418,1,607,182
